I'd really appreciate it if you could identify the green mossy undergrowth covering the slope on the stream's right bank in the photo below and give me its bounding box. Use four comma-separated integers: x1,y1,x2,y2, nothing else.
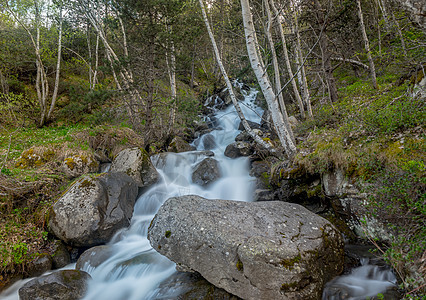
296,77,426,297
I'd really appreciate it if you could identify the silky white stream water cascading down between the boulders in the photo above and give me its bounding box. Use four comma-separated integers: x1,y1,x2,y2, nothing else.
0,85,393,300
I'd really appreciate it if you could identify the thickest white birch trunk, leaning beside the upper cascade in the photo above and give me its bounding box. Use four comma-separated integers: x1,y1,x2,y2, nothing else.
240,0,296,158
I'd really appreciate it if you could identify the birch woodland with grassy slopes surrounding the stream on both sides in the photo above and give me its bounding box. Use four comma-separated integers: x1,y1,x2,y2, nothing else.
0,0,426,298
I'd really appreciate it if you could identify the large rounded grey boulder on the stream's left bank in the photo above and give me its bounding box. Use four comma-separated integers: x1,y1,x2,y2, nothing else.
48,173,138,247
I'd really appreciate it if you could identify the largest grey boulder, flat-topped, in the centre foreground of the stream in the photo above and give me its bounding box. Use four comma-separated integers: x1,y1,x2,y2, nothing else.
148,195,344,300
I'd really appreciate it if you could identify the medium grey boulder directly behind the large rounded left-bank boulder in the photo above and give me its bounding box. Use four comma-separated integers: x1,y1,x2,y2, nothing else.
110,148,159,188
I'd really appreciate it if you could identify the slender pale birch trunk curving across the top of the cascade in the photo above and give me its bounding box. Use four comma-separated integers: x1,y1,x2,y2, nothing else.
199,0,278,152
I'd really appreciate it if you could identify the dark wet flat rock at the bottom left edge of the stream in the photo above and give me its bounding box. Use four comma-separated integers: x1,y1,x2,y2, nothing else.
19,270,91,300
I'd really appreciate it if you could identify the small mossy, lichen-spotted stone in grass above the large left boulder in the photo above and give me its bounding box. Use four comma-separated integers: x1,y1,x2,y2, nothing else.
61,153,99,178
